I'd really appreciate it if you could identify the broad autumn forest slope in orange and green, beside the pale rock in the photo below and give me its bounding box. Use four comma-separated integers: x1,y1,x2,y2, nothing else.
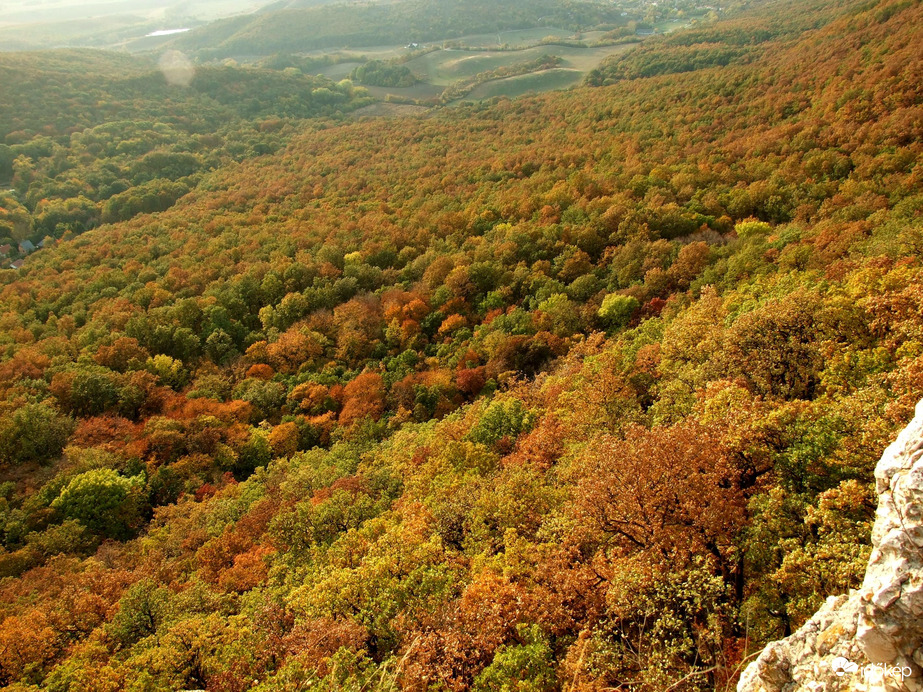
0,0,923,692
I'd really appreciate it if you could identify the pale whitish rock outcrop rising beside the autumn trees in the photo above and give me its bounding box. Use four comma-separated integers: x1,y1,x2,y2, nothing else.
737,401,923,692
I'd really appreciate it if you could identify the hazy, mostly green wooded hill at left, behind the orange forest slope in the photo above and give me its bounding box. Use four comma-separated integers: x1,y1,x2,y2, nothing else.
0,50,372,245
